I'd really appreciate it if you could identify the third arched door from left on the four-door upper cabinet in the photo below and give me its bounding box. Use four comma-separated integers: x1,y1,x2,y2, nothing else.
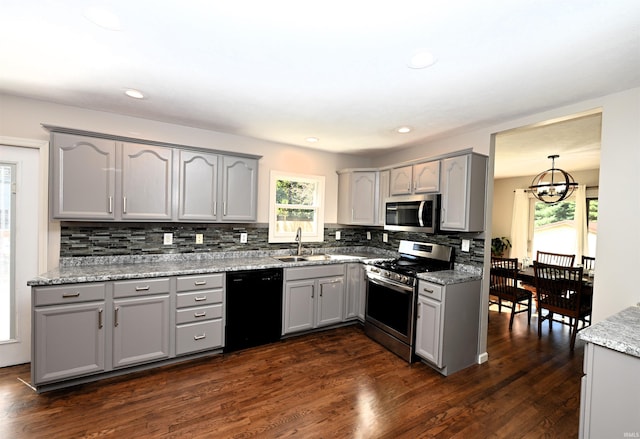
178,150,218,221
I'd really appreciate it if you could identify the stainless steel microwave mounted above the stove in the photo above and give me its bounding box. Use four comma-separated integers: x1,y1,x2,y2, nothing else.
384,194,440,233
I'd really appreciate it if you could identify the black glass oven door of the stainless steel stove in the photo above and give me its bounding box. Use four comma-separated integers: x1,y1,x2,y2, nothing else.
365,277,416,345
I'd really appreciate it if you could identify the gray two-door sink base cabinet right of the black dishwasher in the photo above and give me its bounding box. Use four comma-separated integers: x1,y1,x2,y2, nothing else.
282,264,345,335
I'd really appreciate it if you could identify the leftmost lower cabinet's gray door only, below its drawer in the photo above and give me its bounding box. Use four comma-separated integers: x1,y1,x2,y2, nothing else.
32,302,105,384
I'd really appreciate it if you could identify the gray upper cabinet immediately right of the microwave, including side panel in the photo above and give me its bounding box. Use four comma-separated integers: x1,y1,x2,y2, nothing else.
440,154,487,232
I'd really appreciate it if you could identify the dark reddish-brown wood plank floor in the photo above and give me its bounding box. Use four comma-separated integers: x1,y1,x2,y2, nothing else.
0,312,584,439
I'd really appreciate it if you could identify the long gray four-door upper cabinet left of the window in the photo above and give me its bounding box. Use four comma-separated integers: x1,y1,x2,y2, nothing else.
45,126,260,222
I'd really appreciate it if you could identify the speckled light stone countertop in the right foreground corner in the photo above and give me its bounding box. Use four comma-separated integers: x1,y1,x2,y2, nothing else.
578,306,640,357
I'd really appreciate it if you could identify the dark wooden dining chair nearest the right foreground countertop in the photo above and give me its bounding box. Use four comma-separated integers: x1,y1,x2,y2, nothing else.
533,262,592,350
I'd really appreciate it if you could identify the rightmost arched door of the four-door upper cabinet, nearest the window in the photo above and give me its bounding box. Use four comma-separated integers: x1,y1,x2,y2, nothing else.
222,156,258,221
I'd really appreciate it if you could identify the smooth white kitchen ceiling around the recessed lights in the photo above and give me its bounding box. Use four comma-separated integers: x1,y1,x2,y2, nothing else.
0,0,640,157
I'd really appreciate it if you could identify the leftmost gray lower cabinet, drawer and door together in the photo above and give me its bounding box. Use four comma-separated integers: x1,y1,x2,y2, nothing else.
31,283,106,385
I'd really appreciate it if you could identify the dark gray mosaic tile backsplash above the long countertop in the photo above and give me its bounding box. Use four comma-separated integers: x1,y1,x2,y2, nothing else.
60,222,484,266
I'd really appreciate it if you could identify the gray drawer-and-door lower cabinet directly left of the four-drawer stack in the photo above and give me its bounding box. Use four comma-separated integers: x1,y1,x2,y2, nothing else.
112,278,170,368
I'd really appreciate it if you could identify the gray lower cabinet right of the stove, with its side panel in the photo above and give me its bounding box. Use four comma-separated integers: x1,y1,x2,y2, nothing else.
415,280,480,375
